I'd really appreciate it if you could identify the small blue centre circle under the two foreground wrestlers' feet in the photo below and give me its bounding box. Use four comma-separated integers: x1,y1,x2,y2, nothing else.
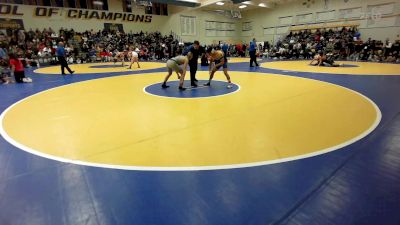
144,80,240,98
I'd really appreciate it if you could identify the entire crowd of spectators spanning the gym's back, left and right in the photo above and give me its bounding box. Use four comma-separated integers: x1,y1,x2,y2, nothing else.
0,27,400,83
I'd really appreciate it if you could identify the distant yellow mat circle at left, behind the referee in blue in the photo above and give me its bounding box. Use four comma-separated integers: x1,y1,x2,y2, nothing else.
34,62,166,74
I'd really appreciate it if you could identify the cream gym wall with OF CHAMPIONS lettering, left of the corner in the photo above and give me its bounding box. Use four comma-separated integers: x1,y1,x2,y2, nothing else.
0,0,240,44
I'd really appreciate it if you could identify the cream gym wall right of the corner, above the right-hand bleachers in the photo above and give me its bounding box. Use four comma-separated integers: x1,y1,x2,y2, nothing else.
238,0,400,42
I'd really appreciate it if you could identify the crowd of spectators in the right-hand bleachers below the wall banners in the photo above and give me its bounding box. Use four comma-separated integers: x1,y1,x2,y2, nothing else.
262,27,400,63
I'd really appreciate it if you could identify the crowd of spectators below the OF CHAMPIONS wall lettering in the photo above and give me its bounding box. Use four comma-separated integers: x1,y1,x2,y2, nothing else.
0,28,183,83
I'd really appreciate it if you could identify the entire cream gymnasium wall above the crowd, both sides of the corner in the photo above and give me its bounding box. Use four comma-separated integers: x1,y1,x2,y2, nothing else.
0,0,400,44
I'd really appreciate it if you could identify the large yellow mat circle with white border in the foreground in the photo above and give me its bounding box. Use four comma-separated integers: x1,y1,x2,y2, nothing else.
0,72,381,170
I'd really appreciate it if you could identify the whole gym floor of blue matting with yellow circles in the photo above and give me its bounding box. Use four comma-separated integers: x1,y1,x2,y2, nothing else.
0,58,400,225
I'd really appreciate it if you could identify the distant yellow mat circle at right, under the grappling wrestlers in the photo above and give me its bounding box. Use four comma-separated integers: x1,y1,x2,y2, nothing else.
261,60,400,75
